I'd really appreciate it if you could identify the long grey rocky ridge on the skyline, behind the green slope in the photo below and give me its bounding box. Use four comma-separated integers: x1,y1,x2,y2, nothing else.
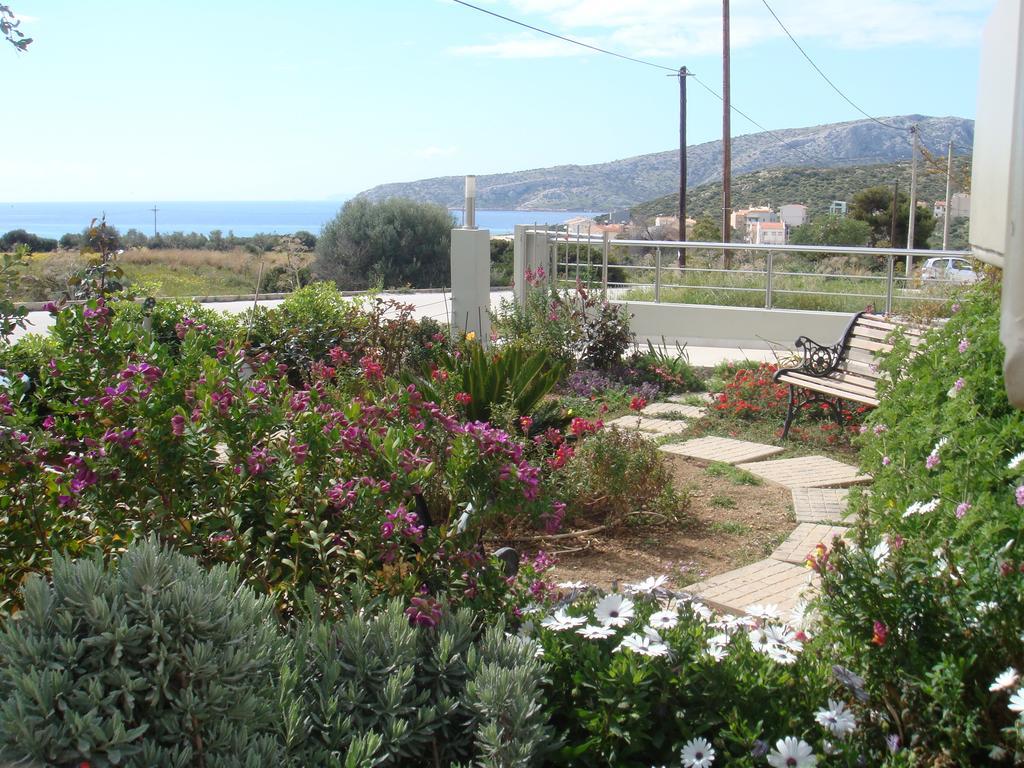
359,115,974,211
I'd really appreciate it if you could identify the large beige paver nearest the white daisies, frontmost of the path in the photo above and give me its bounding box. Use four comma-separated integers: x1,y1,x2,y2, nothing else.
685,558,818,615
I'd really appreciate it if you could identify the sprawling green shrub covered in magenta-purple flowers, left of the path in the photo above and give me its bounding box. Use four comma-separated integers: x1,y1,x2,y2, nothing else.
0,300,555,611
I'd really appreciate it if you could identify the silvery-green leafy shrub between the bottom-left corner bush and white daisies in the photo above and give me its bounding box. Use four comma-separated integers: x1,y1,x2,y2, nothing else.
282,590,550,768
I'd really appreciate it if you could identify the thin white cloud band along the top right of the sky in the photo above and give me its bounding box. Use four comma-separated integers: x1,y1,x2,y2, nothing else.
456,0,994,60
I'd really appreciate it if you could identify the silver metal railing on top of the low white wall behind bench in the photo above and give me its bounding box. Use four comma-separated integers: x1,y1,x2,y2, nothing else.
536,228,971,313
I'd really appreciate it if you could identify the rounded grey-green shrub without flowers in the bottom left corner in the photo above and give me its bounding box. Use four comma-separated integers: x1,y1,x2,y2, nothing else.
0,543,285,768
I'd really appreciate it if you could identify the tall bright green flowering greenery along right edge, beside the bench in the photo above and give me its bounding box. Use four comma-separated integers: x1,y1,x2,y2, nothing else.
818,284,1024,765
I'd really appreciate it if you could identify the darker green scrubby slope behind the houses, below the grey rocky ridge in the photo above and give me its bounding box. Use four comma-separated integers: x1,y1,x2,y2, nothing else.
632,158,971,221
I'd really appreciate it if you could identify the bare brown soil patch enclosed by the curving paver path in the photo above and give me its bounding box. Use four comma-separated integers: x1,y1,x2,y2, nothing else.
544,457,796,589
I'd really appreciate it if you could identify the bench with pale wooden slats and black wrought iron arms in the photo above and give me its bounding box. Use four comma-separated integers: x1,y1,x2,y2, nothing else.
774,309,928,440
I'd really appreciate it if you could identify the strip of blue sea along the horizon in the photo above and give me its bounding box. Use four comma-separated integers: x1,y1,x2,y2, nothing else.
0,200,595,238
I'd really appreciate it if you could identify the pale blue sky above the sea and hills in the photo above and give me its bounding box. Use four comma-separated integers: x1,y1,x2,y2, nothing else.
0,0,994,203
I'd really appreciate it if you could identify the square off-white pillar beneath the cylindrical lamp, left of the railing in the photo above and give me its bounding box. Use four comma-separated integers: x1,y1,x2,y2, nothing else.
452,229,490,347
